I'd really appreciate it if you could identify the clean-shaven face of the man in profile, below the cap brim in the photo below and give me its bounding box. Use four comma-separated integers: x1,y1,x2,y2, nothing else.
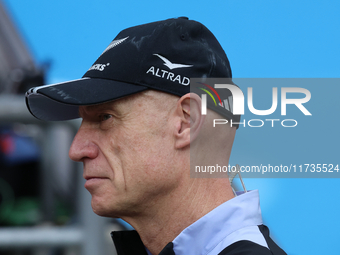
69,91,180,217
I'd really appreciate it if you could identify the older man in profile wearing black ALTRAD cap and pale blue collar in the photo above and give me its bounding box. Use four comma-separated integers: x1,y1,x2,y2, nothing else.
26,18,285,255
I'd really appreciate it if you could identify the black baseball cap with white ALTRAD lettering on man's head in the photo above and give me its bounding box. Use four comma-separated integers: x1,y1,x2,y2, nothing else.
26,17,239,125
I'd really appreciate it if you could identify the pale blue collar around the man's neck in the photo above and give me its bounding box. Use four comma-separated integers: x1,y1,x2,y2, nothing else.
173,190,265,255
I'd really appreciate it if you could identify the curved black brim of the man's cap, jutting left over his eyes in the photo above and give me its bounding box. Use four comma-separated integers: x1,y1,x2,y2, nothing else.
26,78,148,121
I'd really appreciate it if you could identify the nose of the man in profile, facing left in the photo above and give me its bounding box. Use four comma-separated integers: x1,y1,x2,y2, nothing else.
69,124,99,162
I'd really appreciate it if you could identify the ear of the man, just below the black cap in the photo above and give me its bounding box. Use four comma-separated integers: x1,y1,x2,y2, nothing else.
175,93,205,149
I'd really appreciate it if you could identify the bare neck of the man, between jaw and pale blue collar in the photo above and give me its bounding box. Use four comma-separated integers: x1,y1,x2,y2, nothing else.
123,178,234,255
